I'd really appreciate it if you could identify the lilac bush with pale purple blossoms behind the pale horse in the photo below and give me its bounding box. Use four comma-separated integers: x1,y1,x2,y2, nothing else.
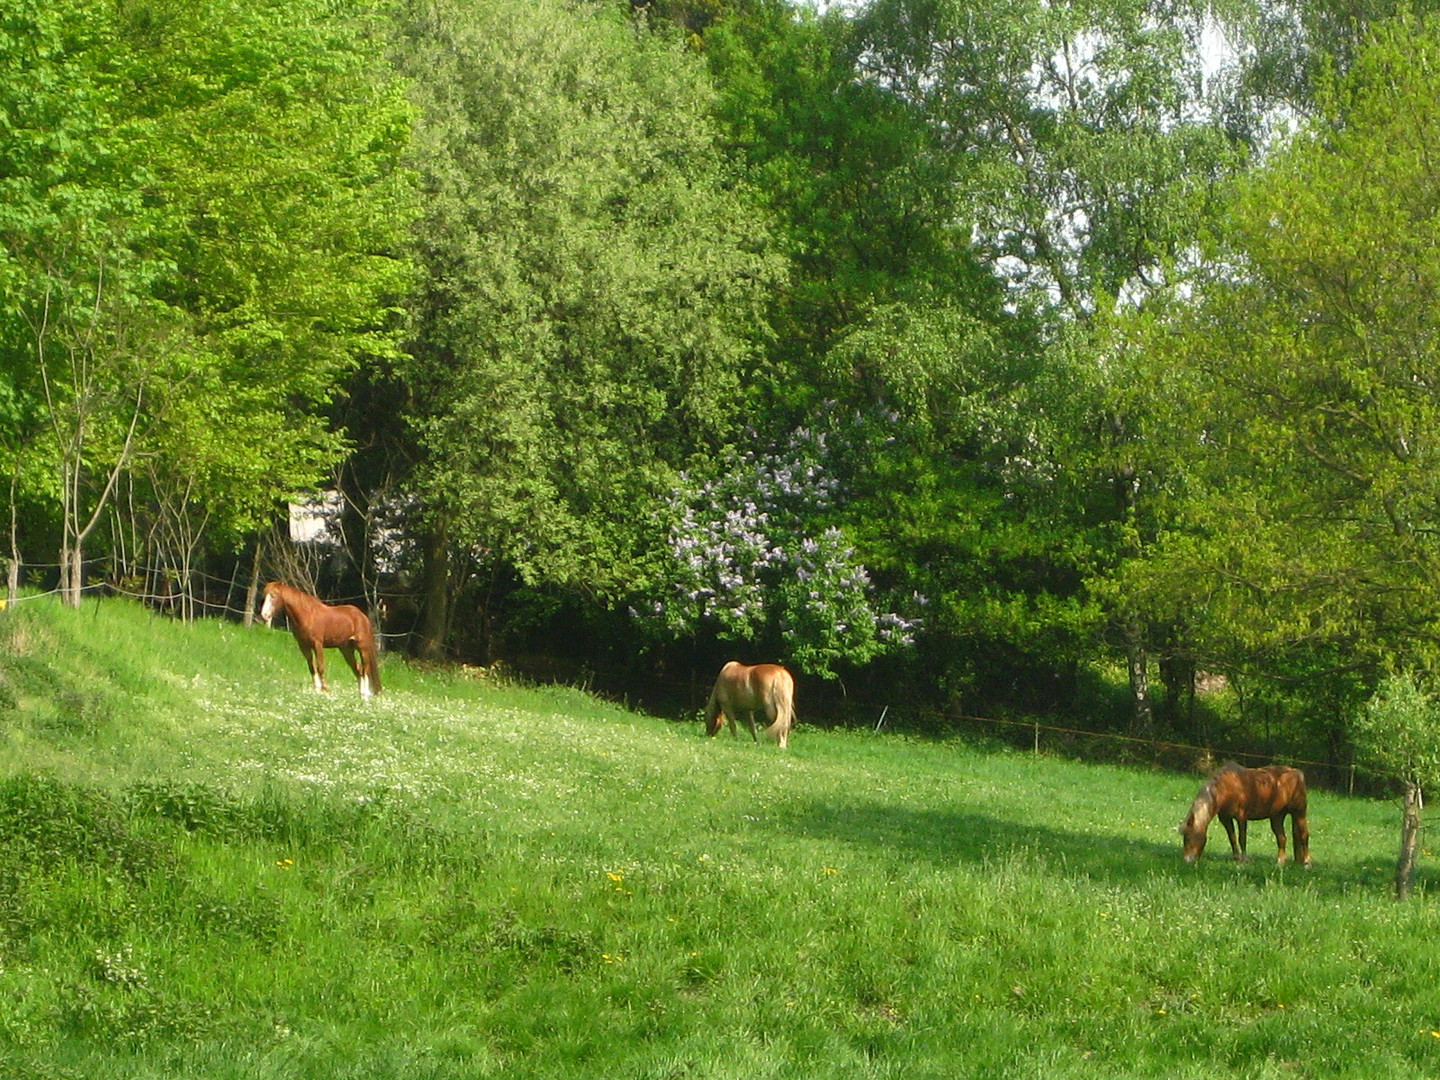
652,428,919,677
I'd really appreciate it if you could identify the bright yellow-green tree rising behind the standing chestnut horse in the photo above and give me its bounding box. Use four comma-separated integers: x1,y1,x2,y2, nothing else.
116,0,413,610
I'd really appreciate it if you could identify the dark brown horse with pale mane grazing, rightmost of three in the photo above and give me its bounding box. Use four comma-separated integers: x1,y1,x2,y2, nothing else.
1179,762,1310,867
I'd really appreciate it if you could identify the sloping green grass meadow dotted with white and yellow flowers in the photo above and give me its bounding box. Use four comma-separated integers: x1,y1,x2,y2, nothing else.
0,600,1440,1080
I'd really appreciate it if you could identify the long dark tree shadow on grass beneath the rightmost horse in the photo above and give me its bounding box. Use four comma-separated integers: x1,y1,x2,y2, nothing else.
785,799,1440,896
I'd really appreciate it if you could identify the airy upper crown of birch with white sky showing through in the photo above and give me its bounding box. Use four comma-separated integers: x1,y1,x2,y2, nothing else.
860,0,1234,318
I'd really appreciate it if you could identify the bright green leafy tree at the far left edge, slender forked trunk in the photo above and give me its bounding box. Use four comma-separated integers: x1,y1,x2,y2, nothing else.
0,0,179,603
